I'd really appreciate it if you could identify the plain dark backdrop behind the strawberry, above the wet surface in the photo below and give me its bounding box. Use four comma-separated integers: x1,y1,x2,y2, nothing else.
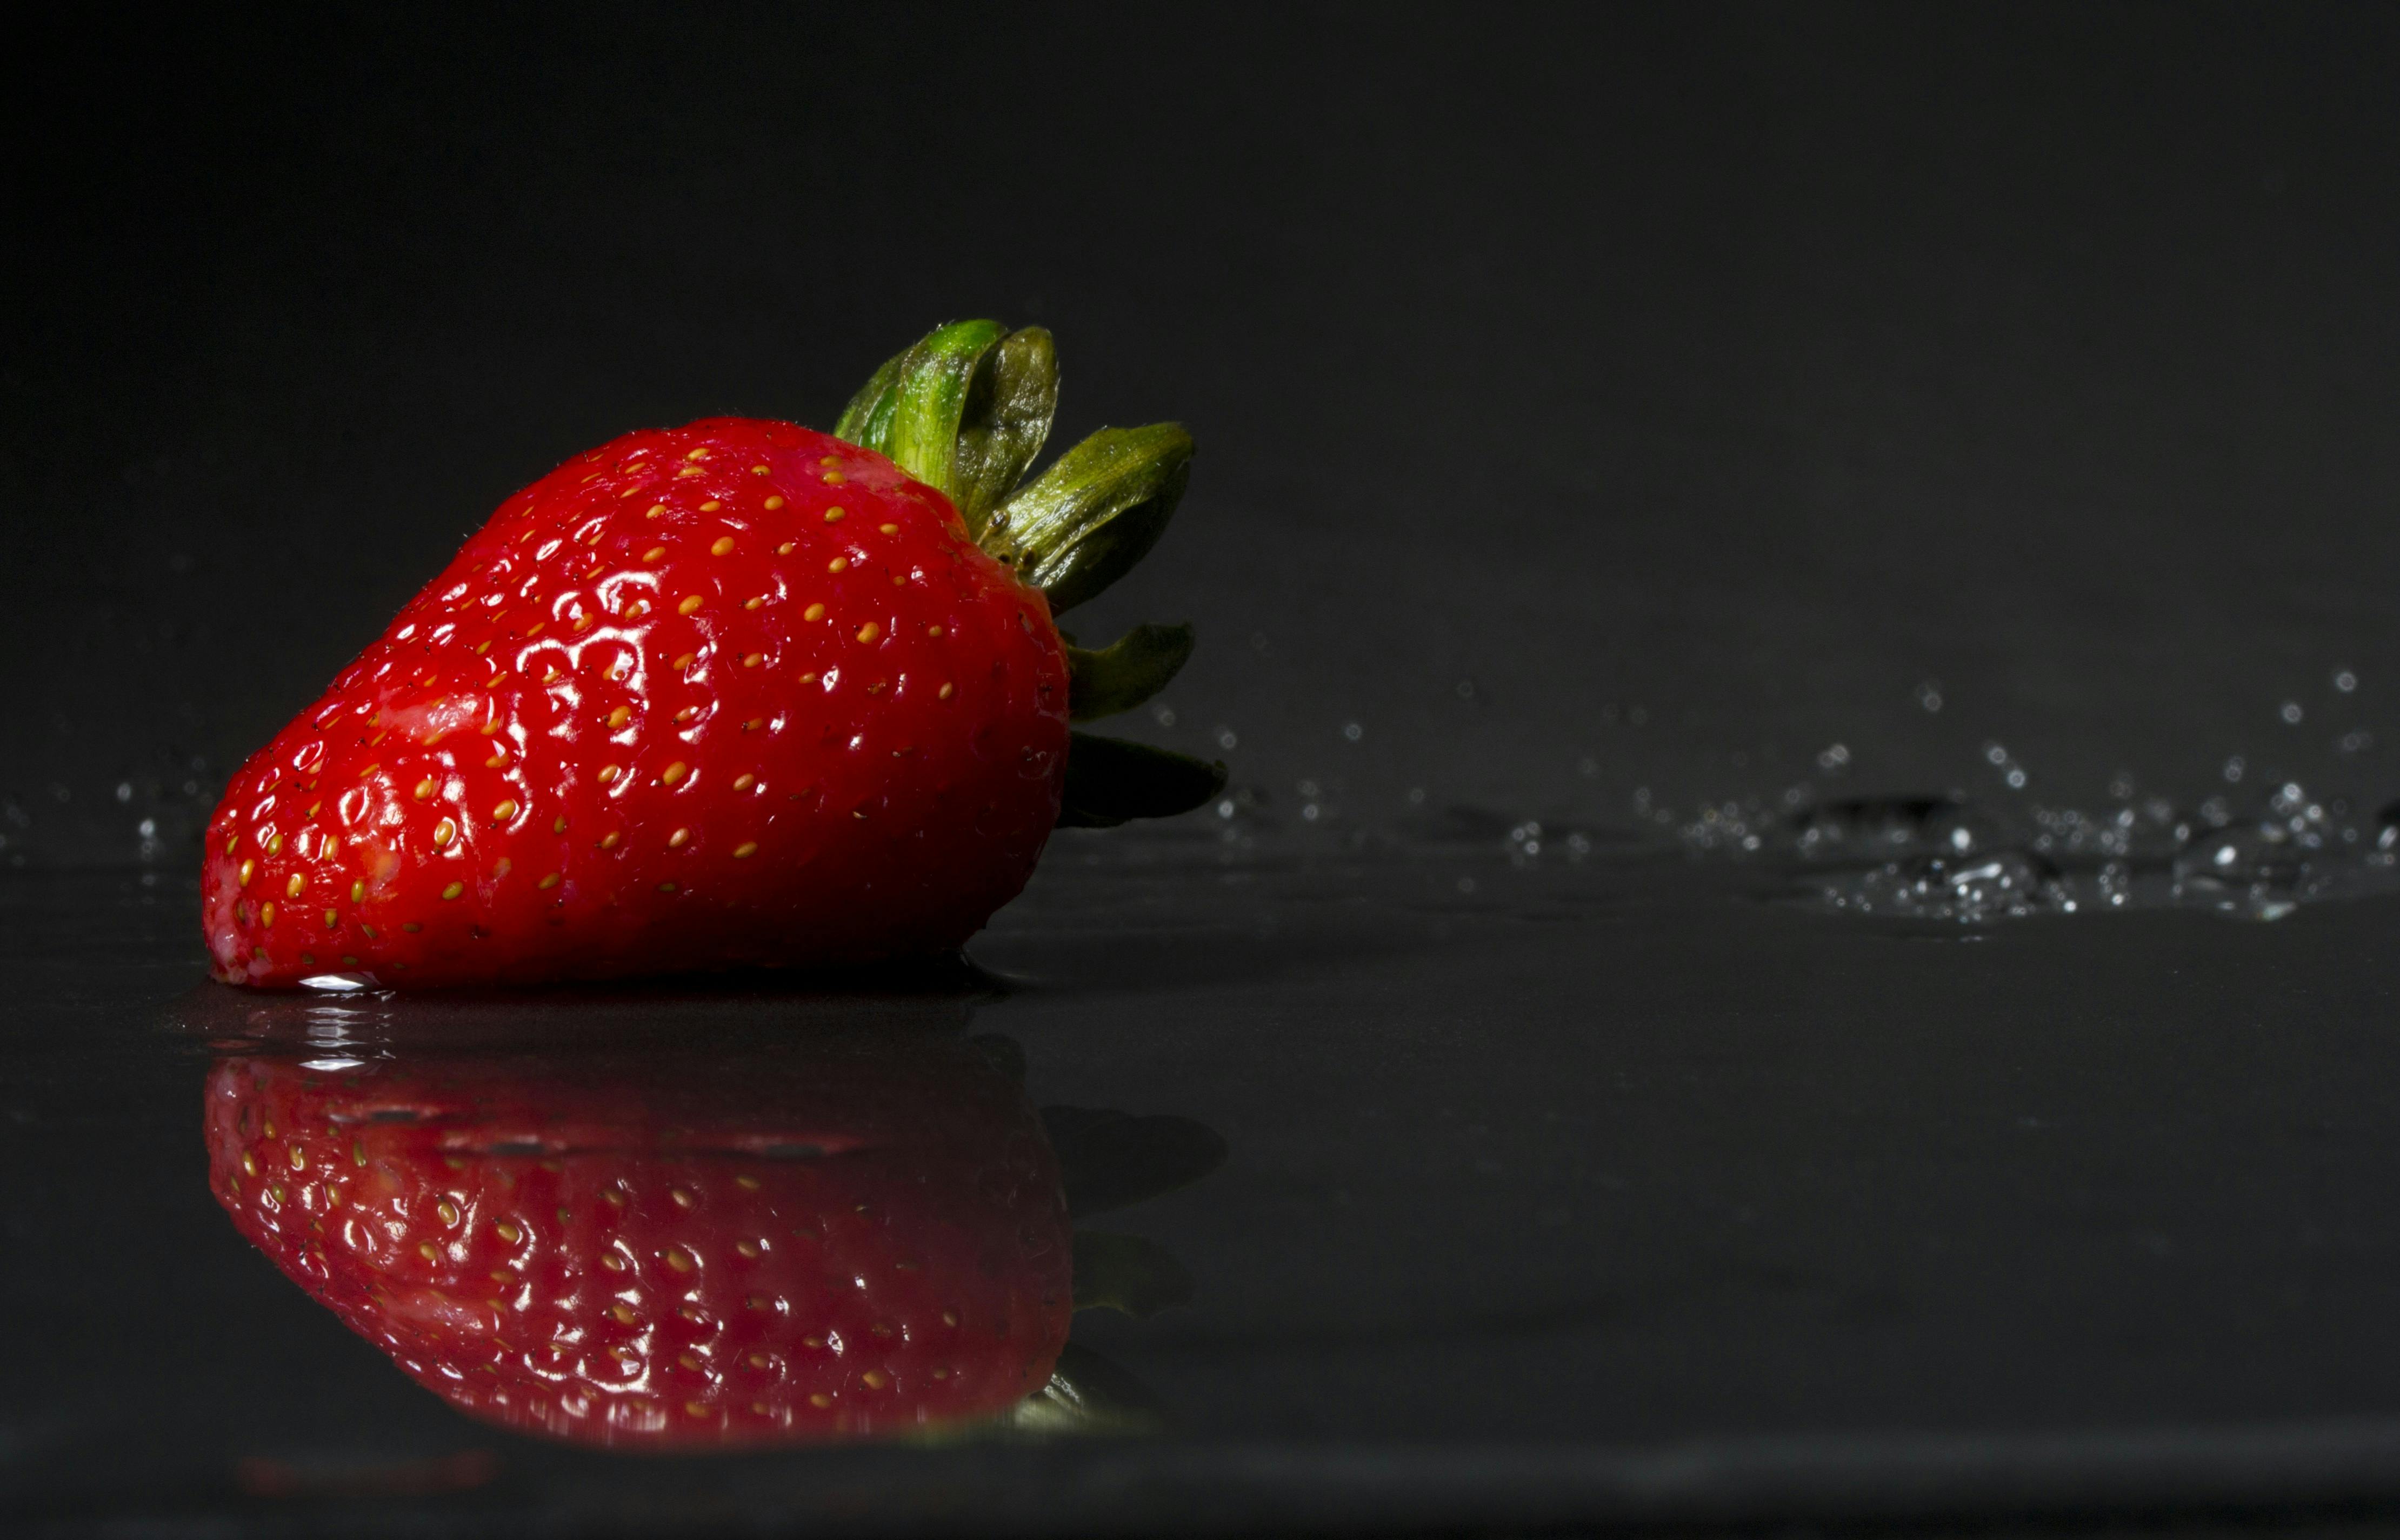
0,5,2400,866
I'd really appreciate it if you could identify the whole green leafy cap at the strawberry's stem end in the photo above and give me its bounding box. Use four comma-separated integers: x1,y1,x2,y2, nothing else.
833,322,1226,828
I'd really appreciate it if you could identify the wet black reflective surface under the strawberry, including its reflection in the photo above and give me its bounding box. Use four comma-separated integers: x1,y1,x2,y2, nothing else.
23,813,2400,1533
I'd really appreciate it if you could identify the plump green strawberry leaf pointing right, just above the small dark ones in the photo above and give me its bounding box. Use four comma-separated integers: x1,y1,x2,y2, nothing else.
979,422,1193,614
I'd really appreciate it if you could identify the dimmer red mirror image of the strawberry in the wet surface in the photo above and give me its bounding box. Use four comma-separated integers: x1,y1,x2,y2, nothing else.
206,1041,1073,1449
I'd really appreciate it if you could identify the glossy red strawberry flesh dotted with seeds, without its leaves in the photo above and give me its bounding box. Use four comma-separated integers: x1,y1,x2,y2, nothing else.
202,417,1068,986
